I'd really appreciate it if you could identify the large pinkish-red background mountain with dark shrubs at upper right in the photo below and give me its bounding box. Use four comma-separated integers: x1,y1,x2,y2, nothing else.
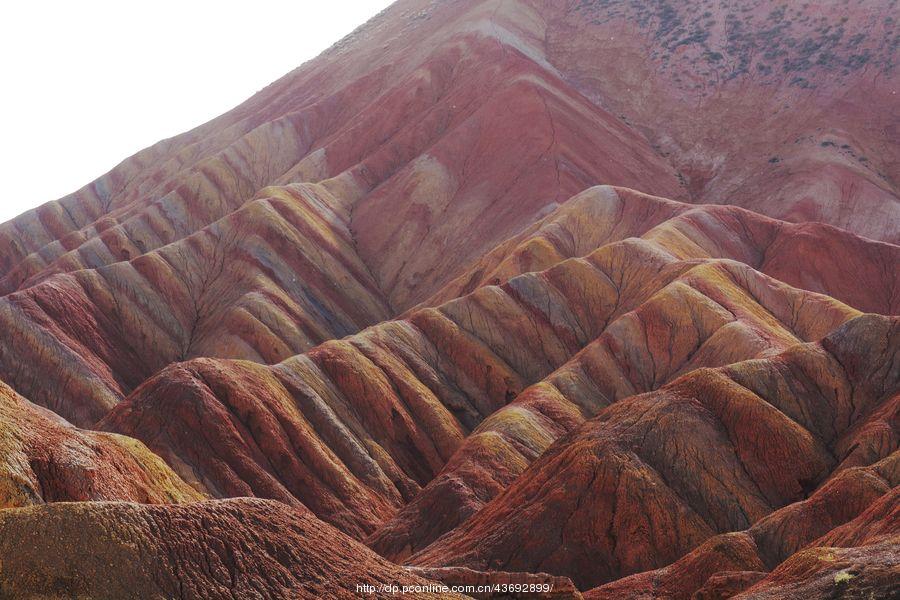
0,0,898,308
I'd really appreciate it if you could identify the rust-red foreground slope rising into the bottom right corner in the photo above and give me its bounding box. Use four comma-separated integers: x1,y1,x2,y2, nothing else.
586,452,900,600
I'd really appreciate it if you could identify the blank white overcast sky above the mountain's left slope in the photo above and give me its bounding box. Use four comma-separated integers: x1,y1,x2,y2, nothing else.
0,0,390,222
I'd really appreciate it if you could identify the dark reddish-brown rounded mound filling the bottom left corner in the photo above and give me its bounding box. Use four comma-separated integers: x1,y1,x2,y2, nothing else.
0,499,461,599
